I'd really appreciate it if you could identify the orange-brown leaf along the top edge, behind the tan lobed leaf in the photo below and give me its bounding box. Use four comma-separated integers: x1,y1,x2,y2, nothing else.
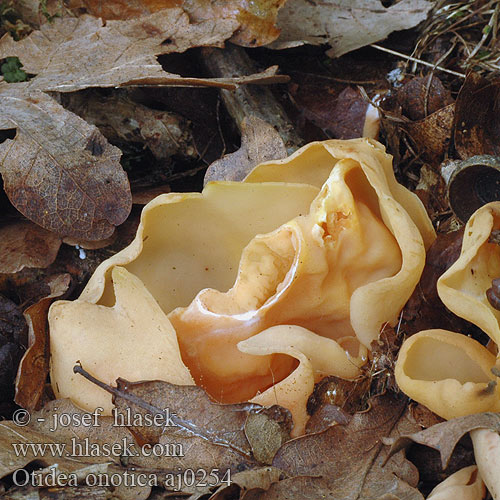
69,0,286,47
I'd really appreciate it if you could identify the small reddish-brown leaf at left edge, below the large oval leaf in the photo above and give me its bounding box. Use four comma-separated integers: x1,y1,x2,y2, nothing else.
0,220,61,273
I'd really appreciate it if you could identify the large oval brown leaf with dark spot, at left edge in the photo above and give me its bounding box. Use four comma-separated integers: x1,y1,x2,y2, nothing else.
0,91,132,240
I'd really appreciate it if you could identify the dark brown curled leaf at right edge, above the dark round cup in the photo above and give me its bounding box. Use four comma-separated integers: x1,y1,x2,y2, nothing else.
454,72,500,159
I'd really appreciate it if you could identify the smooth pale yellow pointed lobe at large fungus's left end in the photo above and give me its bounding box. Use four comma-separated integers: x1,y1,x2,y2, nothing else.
51,267,194,414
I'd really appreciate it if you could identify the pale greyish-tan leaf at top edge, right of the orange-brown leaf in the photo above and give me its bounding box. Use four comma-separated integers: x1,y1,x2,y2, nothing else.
272,0,433,57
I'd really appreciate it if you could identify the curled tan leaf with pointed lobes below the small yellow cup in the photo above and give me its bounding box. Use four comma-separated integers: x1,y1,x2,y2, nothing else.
387,412,500,469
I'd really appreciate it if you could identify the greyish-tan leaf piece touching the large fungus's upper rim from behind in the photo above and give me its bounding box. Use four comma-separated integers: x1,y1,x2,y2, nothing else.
205,116,287,184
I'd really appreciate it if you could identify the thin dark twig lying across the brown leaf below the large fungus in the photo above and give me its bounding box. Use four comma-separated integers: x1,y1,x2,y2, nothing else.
73,365,252,458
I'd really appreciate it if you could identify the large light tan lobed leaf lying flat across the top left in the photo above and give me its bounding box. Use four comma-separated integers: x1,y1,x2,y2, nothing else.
0,9,283,92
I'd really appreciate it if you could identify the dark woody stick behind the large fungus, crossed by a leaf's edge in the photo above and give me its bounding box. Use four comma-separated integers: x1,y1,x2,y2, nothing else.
202,44,304,154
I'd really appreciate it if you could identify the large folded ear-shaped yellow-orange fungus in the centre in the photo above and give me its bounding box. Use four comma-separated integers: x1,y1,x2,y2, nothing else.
49,139,434,432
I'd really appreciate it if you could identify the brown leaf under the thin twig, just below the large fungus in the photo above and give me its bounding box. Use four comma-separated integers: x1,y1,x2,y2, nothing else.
109,379,291,471
